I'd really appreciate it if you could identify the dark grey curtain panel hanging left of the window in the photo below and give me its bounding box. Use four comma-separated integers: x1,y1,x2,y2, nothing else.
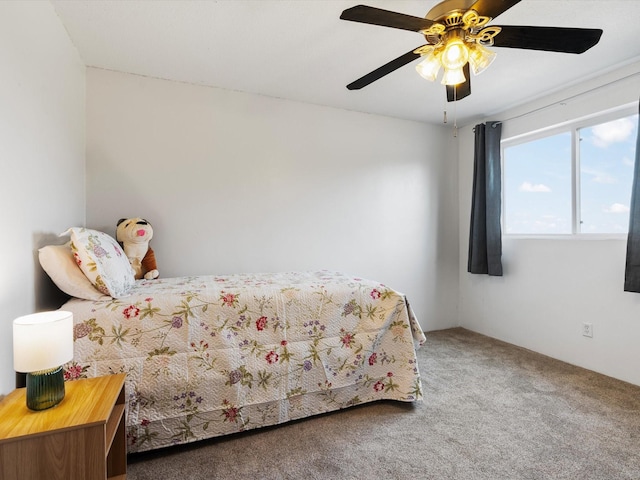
467,122,502,278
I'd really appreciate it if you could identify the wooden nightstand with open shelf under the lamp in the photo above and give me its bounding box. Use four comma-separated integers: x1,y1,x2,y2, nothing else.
0,374,127,480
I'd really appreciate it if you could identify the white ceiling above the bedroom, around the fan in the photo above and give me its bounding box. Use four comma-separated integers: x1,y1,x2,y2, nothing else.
51,0,640,125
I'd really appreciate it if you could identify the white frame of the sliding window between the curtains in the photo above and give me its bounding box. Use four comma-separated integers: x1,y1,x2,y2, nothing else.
500,103,640,240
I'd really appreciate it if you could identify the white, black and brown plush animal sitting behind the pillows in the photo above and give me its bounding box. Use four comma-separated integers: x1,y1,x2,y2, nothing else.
116,218,160,280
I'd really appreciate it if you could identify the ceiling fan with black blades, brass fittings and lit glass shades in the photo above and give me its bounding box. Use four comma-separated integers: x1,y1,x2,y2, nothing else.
340,0,602,102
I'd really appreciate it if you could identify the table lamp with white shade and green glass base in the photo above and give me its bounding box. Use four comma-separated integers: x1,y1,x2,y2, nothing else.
13,310,73,410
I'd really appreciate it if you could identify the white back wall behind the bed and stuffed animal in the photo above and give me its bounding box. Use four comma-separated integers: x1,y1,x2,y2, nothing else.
87,68,458,329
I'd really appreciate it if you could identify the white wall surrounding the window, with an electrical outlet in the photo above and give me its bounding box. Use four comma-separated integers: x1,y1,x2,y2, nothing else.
459,63,640,385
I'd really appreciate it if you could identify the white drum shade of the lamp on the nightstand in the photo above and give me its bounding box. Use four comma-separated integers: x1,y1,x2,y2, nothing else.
13,310,73,373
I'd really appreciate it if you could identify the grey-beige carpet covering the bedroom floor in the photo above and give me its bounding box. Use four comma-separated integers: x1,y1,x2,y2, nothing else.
127,328,640,480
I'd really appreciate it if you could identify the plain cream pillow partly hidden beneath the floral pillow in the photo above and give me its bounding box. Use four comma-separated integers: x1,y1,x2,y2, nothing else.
38,243,109,300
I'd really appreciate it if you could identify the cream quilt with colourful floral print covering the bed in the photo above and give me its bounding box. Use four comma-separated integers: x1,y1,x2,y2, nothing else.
62,271,425,453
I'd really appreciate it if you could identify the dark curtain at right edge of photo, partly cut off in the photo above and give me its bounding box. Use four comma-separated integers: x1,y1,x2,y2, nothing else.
624,99,640,293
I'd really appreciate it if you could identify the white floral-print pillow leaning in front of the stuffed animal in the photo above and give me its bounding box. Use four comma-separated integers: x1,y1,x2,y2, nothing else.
65,227,135,298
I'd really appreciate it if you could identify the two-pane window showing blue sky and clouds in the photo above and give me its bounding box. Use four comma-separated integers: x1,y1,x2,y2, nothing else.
502,108,638,235
